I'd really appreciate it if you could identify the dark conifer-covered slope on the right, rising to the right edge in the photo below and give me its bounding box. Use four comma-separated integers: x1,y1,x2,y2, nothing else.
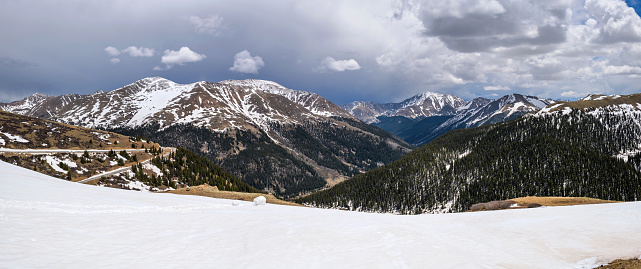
300,94,641,214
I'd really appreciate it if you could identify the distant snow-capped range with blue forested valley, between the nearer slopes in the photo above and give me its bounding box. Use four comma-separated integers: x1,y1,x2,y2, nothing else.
342,92,555,145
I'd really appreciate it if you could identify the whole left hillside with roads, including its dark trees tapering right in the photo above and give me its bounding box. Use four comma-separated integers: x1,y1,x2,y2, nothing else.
0,111,259,192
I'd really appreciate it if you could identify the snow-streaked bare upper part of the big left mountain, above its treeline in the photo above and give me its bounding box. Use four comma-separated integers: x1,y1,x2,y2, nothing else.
0,77,351,131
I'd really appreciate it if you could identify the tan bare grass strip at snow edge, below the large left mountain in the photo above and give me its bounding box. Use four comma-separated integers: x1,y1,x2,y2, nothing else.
168,184,302,206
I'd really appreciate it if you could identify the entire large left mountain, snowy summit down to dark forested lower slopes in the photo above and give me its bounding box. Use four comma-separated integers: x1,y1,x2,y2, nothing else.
0,77,412,195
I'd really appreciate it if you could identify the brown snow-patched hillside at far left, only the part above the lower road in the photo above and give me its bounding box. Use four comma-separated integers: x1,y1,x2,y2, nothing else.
0,111,161,181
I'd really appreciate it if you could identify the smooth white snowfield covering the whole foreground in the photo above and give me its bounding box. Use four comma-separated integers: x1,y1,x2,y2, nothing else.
0,162,641,268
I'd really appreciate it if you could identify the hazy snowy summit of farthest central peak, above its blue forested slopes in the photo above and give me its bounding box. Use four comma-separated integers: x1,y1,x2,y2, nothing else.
341,92,465,123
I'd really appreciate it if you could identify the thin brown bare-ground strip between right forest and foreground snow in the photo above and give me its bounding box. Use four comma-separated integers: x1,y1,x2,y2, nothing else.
468,196,618,212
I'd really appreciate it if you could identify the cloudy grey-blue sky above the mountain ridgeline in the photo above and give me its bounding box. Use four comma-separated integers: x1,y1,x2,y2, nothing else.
0,0,641,104
